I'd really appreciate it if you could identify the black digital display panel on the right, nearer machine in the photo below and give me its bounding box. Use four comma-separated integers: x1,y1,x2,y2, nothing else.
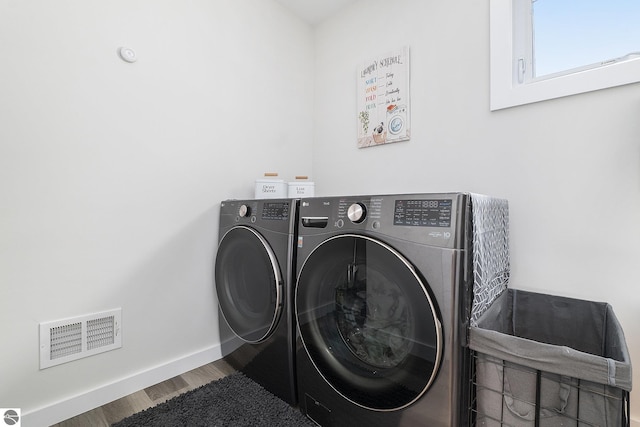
393,199,453,227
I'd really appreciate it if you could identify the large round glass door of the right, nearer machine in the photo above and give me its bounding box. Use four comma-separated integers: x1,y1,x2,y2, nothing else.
295,234,442,411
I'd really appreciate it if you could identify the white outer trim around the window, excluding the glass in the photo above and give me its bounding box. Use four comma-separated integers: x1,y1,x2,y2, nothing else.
489,0,640,111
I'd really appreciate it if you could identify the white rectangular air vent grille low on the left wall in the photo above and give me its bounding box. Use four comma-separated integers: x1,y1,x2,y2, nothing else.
40,308,122,369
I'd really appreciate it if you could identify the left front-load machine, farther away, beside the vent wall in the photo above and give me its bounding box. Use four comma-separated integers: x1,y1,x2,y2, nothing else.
215,199,298,405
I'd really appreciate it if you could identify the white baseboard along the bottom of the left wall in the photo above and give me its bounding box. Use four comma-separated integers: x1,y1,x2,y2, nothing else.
22,344,238,427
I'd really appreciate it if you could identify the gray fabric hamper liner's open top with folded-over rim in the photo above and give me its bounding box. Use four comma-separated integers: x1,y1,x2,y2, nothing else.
469,289,632,391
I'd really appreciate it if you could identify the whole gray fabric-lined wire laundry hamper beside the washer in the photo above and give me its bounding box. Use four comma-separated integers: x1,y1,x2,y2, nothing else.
469,289,631,427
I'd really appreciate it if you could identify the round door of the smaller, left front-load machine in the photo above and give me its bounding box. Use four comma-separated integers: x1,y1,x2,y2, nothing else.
215,226,282,343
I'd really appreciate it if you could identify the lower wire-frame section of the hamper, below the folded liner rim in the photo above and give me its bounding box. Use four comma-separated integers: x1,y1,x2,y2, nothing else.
471,352,629,427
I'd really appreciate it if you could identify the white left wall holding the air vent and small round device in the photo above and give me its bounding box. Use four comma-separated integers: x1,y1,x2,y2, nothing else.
0,0,313,425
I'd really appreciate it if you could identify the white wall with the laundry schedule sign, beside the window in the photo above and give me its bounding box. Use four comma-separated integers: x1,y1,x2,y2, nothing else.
313,0,640,420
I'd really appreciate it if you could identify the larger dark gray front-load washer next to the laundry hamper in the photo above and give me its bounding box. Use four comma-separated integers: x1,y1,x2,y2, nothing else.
295,193,473,427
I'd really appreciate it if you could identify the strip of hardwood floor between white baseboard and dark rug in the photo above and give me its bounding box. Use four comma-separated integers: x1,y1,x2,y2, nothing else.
53,360,235,427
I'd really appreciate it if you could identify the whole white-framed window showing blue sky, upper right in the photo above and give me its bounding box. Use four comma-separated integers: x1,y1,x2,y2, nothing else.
490,0,640,110
